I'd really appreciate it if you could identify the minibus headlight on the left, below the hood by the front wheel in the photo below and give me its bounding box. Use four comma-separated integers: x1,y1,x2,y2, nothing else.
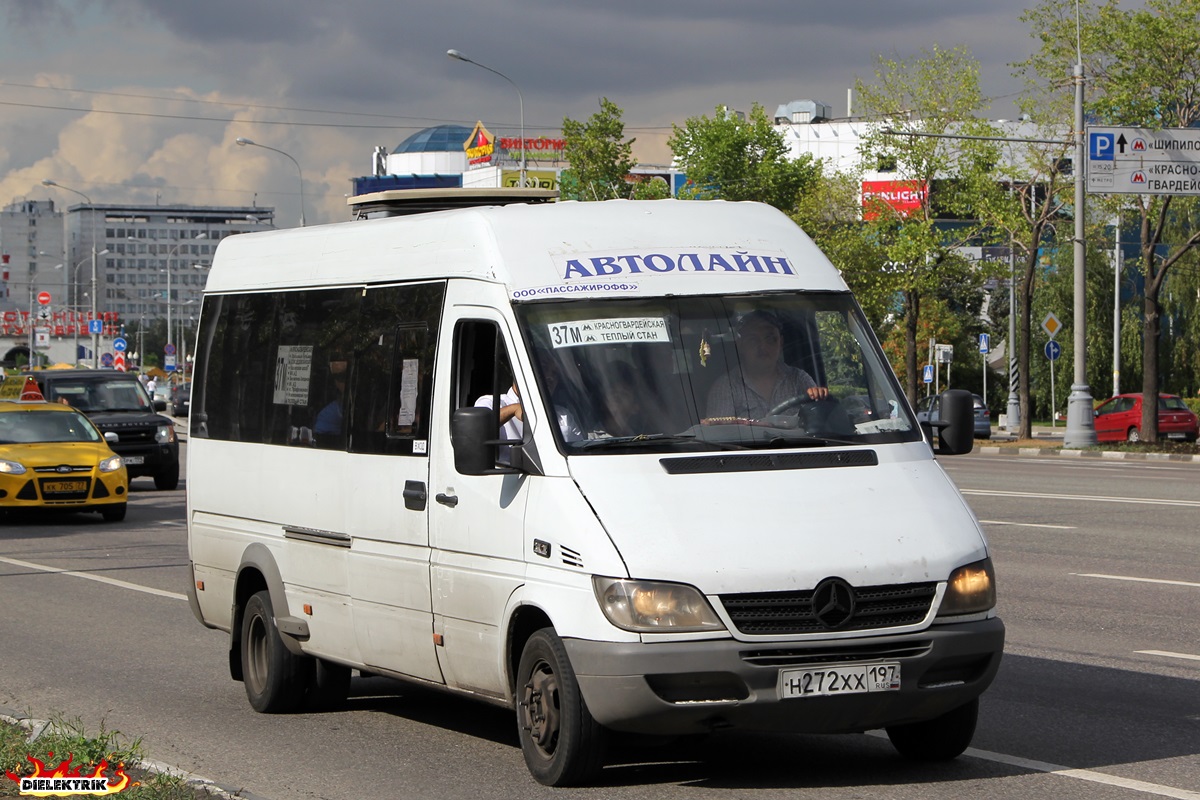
592,576,725,633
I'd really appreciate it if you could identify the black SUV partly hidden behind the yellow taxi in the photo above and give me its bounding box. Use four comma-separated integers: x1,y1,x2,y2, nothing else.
26,369,179,491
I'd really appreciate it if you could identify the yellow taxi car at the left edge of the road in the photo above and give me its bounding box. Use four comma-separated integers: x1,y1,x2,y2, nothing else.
0,378,130,522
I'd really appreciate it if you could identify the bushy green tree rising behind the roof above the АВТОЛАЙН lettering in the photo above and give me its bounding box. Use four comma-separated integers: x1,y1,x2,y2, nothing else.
667,103,820,212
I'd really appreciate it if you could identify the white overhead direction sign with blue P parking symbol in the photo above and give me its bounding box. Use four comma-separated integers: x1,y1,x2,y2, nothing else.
1087,127,1200,196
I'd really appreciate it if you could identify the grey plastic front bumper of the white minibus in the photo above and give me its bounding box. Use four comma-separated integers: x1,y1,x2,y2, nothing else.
564,619,1004,735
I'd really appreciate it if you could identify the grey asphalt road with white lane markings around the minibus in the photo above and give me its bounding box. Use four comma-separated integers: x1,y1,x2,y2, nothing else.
0,455,1200,800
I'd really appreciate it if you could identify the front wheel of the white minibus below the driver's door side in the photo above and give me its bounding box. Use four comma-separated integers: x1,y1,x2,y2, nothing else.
514,627,607,786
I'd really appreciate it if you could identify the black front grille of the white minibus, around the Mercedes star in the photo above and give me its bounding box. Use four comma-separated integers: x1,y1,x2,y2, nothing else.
720,583,937,636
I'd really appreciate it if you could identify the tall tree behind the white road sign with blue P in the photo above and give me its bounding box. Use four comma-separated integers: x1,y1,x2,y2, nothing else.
1026,0,1200,441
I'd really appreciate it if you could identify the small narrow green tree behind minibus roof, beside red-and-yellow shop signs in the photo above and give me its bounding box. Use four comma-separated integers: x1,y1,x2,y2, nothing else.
559,97,637,200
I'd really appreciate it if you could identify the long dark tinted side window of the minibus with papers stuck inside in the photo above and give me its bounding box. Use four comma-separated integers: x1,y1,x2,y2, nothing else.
191,283,444,453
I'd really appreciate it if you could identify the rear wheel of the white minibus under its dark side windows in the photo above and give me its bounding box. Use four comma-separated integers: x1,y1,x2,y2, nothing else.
241,589,313,714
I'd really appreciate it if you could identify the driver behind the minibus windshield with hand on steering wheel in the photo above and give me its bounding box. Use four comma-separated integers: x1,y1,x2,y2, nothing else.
706,309,829,420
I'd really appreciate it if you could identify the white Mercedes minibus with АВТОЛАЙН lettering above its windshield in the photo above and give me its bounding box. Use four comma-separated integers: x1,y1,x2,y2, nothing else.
187,200,1004,786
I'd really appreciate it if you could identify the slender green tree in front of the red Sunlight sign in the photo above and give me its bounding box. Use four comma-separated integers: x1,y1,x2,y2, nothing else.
856,47,997,402
